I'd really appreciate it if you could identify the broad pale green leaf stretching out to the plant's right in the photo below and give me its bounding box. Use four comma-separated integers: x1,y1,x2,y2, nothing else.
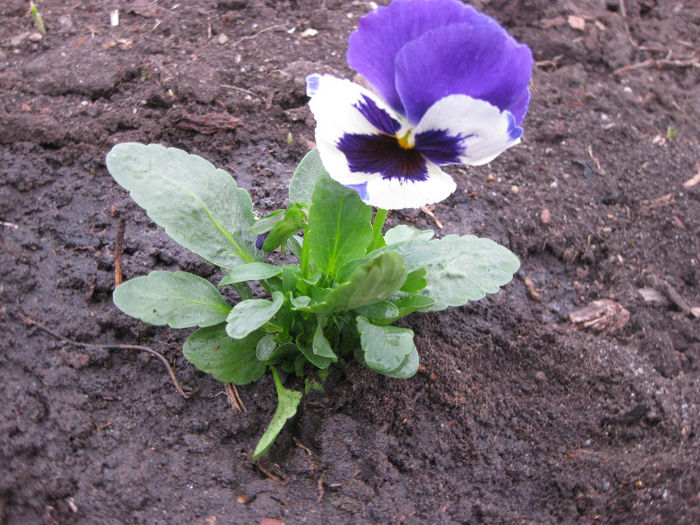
373,235,520,311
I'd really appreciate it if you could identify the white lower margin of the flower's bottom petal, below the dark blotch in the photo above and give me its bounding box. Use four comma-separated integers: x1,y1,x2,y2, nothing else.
365,162,457,210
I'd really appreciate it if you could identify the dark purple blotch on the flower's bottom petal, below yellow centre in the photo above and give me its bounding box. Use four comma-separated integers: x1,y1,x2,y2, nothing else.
337,133,428,181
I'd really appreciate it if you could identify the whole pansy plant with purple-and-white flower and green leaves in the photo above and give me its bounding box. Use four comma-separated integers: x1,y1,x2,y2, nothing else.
107,0,532,459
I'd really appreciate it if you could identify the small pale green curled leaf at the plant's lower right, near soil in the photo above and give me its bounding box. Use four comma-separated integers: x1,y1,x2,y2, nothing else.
357,315,418,378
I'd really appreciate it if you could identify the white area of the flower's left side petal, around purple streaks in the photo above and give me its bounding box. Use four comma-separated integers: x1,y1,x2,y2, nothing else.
306,75,401,184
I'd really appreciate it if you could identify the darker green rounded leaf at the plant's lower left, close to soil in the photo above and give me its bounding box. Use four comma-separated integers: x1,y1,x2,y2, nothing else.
182,324,265,385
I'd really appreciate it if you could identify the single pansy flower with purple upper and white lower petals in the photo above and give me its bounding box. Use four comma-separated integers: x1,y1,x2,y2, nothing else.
307,0,533,209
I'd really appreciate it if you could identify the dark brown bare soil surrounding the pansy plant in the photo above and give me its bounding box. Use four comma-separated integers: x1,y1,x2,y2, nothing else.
0,0,700,525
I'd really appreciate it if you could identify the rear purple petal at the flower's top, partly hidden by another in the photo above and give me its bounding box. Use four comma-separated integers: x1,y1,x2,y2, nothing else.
348,0,497,114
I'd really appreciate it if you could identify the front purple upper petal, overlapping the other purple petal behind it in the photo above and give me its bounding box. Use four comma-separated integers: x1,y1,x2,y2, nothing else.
395,24,533,124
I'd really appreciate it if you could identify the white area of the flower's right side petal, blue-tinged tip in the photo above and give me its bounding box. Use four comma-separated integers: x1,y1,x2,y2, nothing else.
415,95,522,166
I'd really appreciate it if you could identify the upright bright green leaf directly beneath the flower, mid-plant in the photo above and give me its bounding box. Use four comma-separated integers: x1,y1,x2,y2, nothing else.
304,173,372,277
